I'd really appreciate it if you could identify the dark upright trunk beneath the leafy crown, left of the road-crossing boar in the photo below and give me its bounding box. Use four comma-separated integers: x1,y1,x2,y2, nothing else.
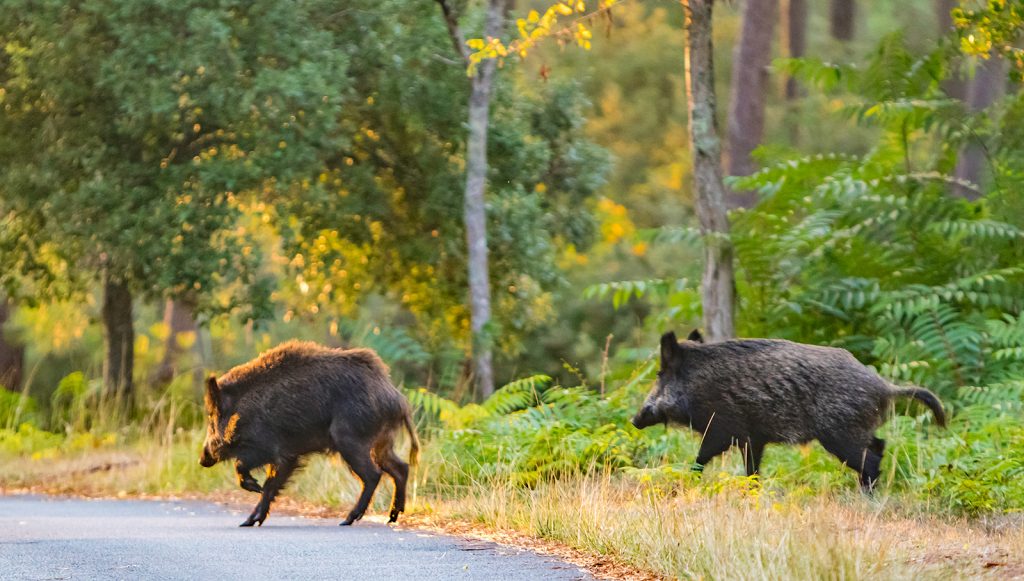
102,276,135,399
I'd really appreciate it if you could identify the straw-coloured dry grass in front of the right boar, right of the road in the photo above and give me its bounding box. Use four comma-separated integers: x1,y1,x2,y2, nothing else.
419,478,1024,579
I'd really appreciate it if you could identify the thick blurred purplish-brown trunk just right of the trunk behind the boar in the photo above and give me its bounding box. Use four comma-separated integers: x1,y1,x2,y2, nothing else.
727,0,778,208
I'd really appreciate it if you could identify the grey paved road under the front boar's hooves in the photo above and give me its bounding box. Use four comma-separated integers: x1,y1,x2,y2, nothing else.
0,496,590,581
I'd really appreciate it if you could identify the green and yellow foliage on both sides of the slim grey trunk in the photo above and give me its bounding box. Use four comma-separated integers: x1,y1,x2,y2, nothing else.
276,2,608,368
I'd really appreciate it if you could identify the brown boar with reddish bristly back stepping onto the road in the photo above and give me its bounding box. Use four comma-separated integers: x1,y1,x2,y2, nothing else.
200,341,420,527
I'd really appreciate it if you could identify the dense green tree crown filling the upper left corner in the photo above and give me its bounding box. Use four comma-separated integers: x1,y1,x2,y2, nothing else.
0,0,346,309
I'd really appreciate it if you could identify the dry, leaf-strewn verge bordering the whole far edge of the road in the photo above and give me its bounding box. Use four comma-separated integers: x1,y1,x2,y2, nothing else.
0,447,1024,579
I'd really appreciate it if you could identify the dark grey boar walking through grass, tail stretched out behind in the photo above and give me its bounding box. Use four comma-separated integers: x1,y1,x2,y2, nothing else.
633,331,946,492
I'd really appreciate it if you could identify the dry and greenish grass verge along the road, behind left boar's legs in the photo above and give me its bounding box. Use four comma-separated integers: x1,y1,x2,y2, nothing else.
0,427,1024,579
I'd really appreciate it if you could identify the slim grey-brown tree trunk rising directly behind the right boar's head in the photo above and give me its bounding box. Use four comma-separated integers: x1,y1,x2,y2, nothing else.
685,0,735,341
